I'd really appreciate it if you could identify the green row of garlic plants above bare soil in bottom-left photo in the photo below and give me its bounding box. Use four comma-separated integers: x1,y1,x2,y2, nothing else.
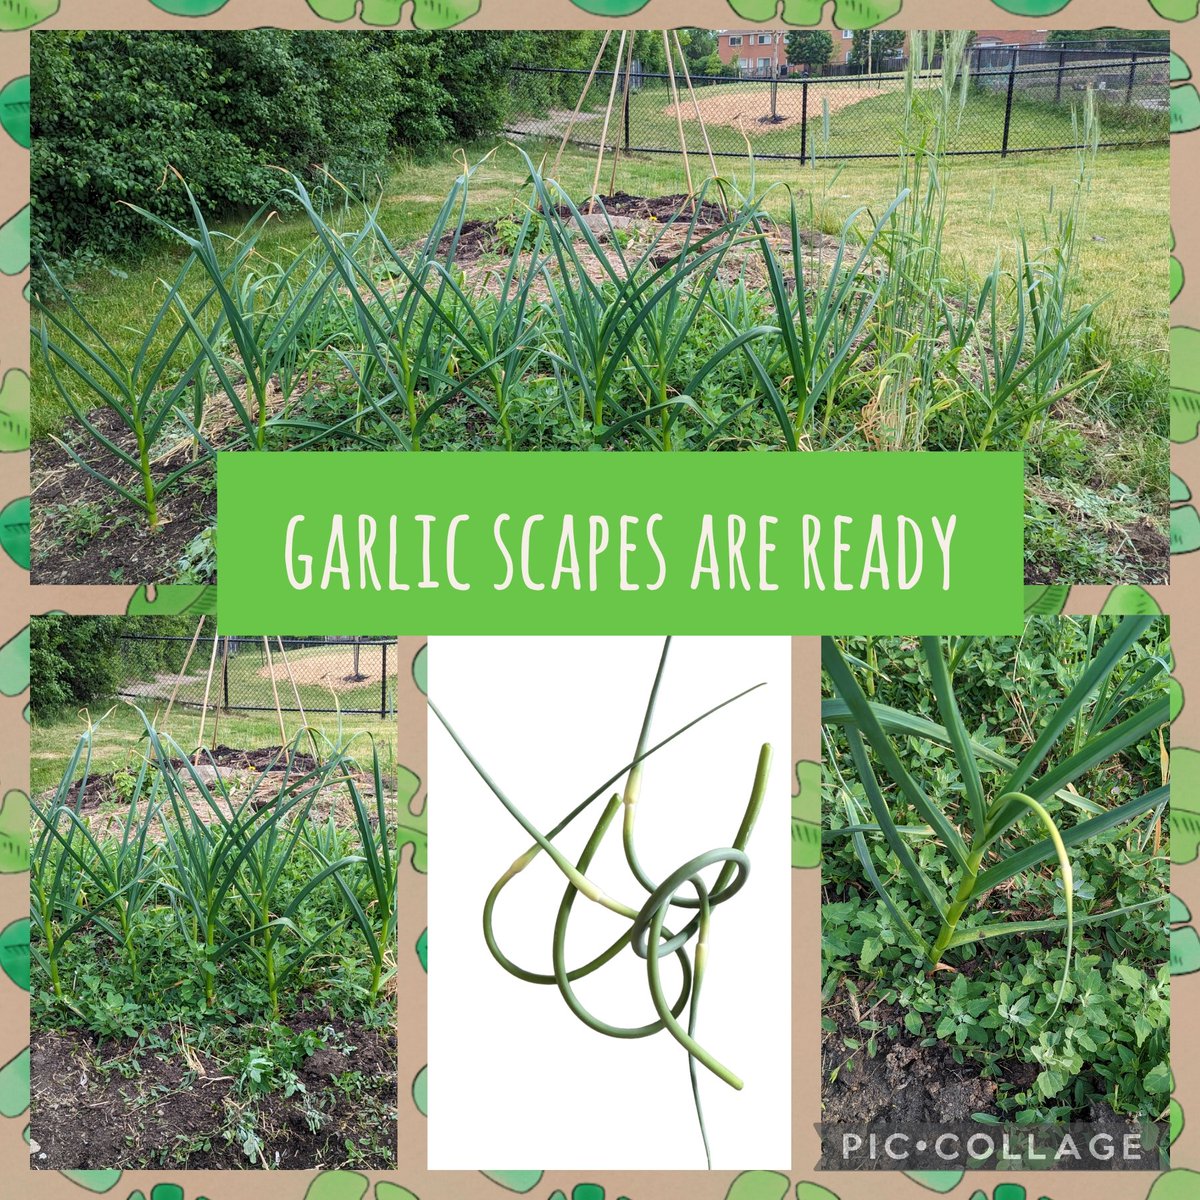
30,718,397,1017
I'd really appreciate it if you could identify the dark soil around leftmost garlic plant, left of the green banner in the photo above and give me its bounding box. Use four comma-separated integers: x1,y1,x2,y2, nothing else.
30,409,217,583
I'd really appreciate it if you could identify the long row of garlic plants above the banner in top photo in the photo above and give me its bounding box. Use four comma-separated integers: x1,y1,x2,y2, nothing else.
34,92,1099,527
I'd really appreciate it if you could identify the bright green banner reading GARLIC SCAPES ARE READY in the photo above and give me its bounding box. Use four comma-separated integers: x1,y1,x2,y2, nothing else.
217,452,1022,635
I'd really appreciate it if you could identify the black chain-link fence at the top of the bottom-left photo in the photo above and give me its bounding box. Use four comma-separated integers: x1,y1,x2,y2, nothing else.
118,634,398,718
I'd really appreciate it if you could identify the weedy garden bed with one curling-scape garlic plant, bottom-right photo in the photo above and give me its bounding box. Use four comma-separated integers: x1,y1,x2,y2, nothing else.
821,617,1171,1169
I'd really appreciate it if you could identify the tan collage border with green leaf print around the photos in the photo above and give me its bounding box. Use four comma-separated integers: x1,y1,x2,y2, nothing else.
0,7,1200,1200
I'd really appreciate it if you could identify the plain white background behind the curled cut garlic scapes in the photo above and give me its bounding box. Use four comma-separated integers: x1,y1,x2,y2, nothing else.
428,637,792,1170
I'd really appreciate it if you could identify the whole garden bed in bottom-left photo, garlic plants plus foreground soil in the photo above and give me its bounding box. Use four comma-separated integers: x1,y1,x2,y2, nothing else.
30,712,398,1170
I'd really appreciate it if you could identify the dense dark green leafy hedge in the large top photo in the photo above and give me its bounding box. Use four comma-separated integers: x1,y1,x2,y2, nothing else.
30,29,598,263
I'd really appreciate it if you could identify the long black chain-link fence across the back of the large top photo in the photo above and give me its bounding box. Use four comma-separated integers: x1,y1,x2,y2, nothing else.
508,47,1170,162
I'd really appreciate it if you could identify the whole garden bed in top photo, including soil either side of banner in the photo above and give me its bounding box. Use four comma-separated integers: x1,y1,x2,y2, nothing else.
31,137,1170,584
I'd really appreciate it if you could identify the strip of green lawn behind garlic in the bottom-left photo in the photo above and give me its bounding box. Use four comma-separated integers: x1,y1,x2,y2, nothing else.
29,700,397,796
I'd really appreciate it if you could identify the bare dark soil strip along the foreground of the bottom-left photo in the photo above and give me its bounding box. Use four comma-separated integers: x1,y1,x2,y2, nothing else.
29,1012,397,1171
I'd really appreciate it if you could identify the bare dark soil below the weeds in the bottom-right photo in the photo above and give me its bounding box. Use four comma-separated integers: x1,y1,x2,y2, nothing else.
817,992,1166,1170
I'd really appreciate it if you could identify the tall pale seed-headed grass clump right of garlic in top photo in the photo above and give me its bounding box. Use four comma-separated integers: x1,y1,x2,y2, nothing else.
874,32,1099,450
